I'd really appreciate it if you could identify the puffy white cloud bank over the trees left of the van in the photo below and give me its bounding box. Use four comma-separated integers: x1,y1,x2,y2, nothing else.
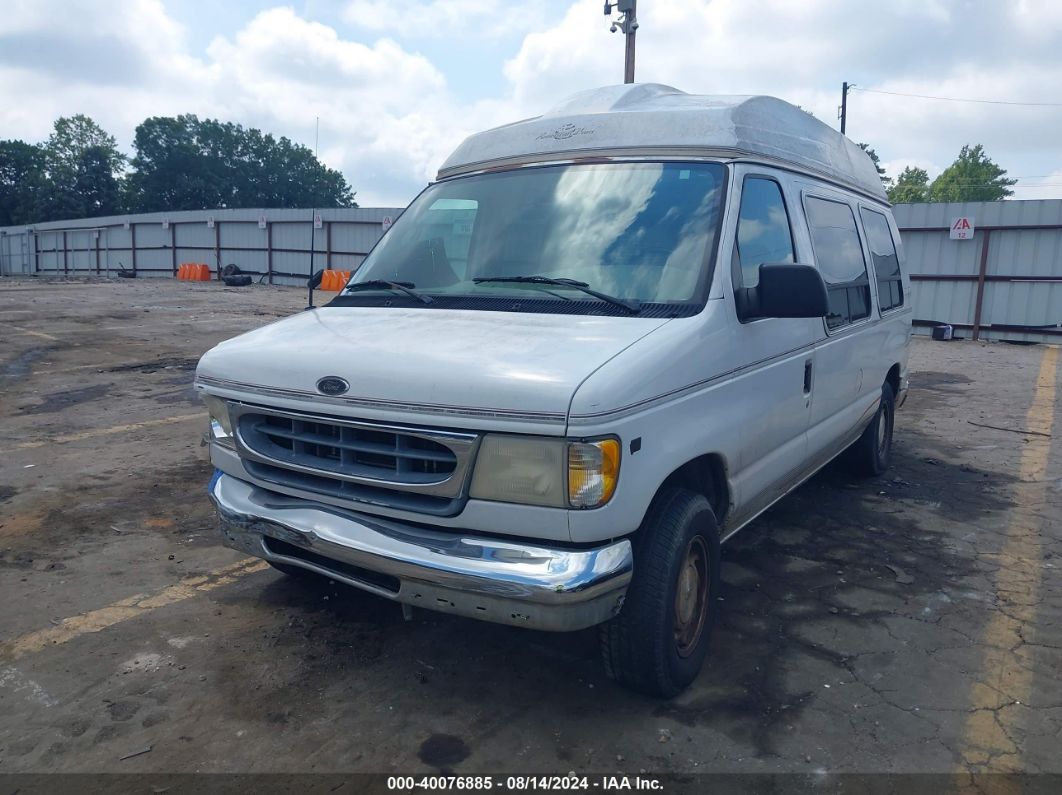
0,0,465,204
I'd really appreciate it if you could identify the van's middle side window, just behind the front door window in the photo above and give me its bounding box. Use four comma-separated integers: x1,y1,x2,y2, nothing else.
805,196,870,329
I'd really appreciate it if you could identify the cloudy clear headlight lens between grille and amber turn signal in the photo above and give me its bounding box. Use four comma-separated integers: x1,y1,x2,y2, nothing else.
469,434,567,508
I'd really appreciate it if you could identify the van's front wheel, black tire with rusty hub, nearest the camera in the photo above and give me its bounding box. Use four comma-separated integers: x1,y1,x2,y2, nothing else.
601,488,720,698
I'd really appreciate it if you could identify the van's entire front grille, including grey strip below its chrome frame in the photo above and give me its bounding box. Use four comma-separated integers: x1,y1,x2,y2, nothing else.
229,403,477,516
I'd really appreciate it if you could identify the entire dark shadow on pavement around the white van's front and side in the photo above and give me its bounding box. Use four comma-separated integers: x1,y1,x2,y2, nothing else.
204,428,1012,762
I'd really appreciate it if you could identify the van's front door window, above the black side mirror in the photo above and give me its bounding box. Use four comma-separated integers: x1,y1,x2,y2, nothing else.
734,176,793,288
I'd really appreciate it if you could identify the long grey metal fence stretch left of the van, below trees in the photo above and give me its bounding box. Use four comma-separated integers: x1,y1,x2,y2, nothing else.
0,207,401,284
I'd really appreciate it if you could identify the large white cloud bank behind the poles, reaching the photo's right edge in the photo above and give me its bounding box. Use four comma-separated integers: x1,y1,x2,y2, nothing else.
504,0,1062,195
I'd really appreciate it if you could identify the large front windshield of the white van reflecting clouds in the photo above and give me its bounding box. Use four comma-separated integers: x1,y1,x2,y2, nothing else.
332,162,725,314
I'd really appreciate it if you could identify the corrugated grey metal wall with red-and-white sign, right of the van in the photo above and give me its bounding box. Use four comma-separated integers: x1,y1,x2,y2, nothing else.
893,200,1062,343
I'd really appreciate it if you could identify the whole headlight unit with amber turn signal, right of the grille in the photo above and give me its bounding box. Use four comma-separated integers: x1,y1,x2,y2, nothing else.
469,434,619,508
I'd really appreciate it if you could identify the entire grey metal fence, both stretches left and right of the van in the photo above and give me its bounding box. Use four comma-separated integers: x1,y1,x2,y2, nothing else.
0,200,1062,342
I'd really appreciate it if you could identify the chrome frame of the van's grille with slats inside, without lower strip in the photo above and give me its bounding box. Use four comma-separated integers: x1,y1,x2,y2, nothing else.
228,401,479,500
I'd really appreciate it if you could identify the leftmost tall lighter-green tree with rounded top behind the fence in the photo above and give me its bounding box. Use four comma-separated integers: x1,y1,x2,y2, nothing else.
41,114,125,221
